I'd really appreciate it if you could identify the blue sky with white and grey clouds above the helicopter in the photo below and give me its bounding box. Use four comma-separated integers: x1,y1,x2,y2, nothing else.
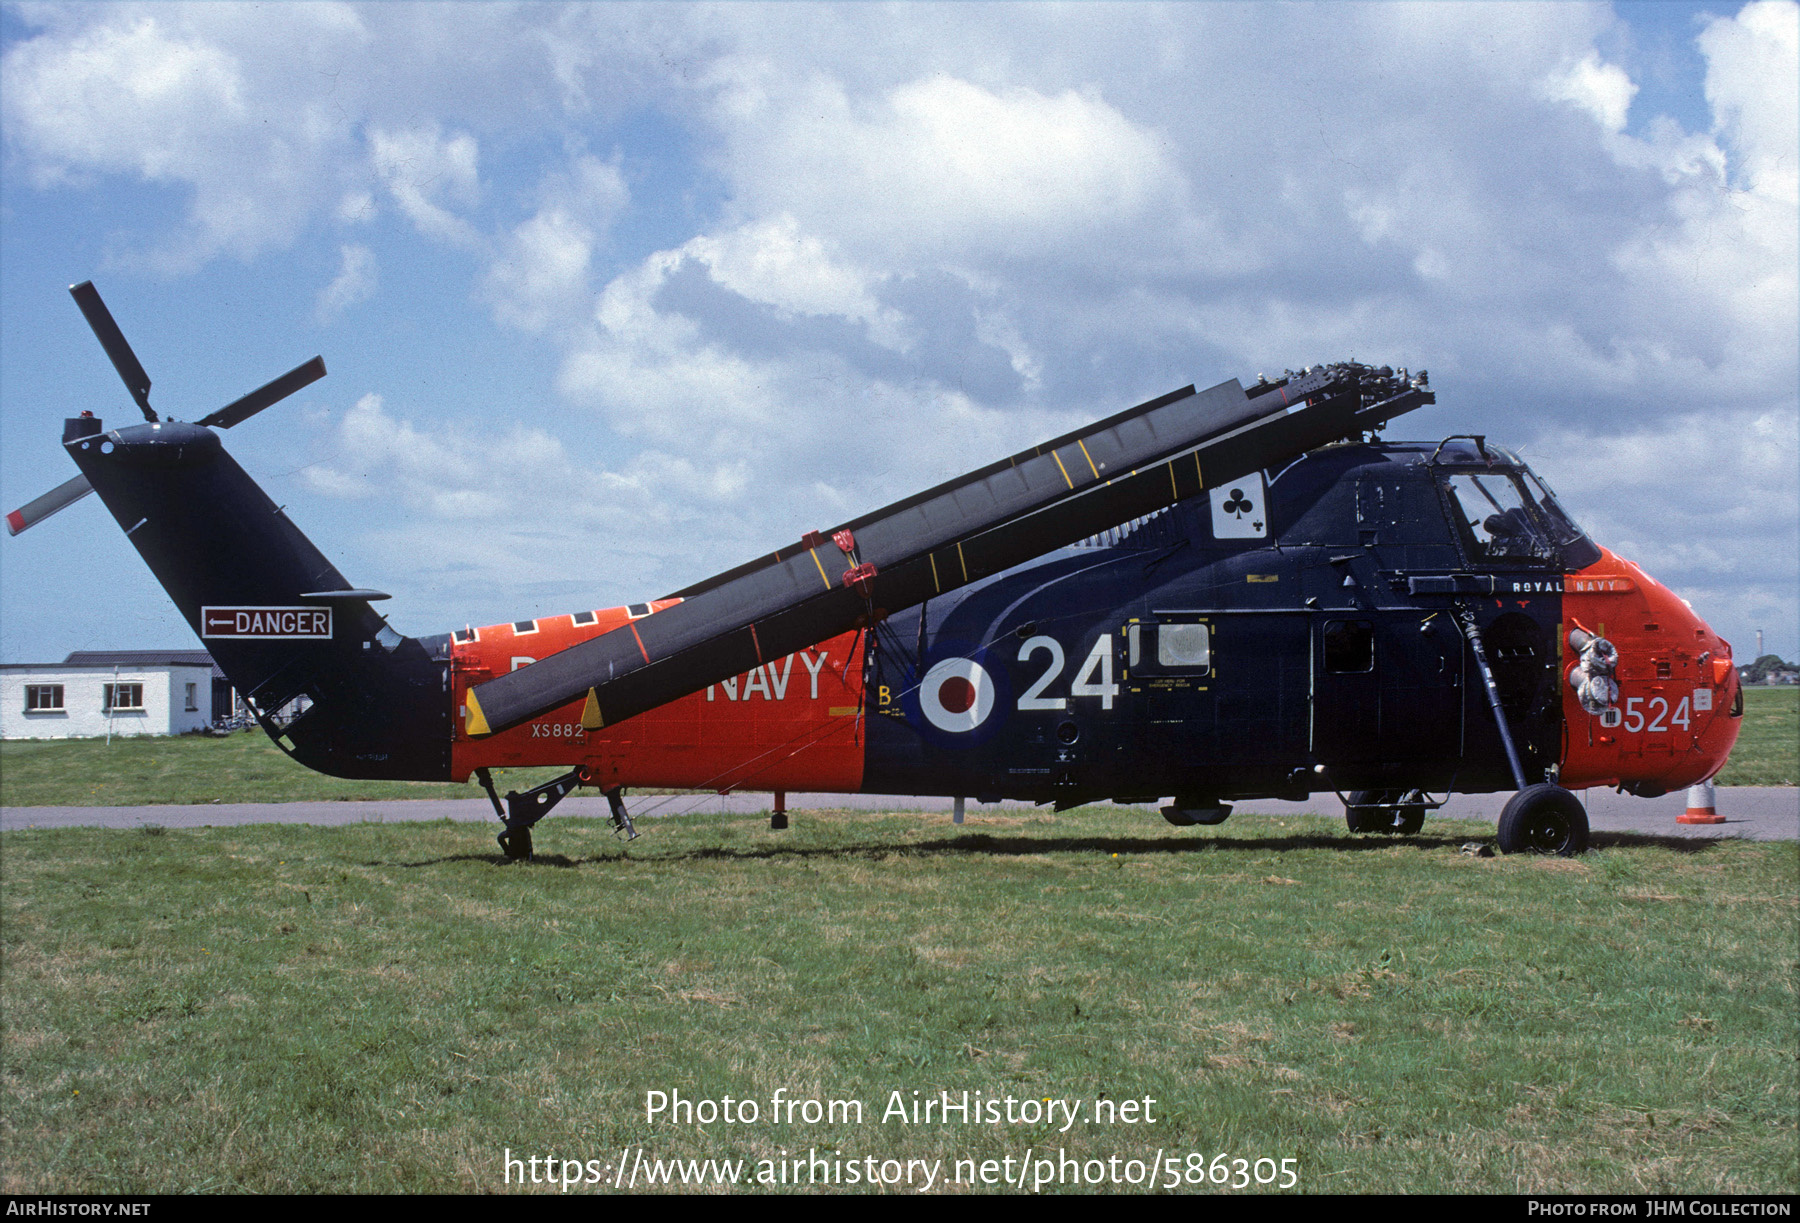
0,0,1800,663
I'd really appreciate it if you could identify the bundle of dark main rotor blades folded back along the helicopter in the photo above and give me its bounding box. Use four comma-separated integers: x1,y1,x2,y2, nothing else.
466,364,1433,735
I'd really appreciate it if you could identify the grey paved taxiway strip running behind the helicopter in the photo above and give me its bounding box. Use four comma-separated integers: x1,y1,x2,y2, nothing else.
0,785,1800,841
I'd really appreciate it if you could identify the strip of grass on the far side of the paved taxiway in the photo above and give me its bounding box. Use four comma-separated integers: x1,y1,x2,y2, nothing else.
0,688,1800,807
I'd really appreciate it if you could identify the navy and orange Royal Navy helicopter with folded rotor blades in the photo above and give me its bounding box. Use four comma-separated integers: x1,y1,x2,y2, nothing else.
7,283,1742,857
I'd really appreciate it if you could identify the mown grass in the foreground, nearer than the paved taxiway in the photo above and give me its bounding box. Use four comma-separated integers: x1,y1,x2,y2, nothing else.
0,809,1800,1192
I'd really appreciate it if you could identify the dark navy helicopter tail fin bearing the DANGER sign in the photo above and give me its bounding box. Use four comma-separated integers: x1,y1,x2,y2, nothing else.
65,420,452,780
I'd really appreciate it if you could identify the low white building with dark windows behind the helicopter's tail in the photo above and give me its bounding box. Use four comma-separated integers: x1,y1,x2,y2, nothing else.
0,650,212,738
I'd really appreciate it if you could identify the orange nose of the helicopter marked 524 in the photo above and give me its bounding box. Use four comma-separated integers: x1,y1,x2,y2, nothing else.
1561,548,1742,796
